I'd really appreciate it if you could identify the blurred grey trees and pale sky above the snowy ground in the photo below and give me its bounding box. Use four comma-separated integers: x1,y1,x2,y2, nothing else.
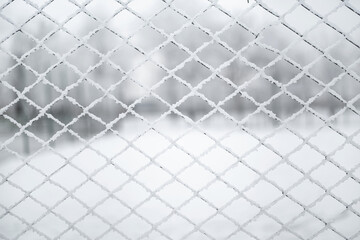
0,0,360,158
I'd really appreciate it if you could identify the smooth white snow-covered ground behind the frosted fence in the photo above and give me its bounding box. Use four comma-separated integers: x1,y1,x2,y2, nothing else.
0,120,360,240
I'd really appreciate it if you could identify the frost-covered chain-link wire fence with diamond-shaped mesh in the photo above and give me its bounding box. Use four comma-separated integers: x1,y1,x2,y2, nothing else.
0,0,360,239
